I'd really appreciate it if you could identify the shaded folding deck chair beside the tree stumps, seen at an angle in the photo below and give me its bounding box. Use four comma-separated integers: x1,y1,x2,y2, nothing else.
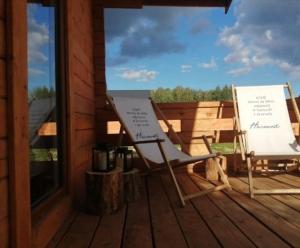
107,91,230,206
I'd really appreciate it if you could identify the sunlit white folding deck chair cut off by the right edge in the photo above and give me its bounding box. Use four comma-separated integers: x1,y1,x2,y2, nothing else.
232,83,300,198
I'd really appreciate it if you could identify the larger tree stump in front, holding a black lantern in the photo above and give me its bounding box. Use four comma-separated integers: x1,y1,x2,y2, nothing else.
85,168,124,215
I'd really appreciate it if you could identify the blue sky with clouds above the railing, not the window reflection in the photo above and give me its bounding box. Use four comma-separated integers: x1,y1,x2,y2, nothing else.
105,0,300,95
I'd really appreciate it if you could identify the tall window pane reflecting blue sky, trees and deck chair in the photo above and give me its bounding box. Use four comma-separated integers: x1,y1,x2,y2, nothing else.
27,0,65,207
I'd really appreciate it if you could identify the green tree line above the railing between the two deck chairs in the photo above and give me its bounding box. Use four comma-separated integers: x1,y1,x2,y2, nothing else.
151,85,232,103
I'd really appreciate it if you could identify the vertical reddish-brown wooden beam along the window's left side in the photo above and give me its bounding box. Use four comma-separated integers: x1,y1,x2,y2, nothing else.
6,0,31,247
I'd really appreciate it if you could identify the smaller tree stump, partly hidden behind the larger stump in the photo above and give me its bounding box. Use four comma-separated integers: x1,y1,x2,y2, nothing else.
123,169,142,202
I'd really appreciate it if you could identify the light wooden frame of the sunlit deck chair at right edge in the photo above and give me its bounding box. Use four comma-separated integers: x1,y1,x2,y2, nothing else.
232,82,300,198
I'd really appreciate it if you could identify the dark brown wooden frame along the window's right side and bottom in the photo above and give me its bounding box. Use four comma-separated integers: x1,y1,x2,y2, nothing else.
27,0,69,215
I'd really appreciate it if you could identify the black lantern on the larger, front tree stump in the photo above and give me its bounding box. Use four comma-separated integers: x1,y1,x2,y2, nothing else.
93,144,115,172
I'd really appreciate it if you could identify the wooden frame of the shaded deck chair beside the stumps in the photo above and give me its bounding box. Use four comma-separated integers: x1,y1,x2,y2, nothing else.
107,95,231,207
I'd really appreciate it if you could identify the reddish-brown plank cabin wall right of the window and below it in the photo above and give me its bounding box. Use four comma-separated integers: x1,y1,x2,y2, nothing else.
32,0,101,247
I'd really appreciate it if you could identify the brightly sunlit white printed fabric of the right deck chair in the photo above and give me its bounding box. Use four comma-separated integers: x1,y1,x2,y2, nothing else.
235,85,300,158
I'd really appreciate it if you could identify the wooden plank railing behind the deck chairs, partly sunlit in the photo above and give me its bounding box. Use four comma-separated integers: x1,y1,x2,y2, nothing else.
101,99,300,155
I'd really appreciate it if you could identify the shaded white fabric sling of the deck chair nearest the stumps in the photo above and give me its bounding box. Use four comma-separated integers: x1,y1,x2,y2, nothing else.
111,92,190,164
